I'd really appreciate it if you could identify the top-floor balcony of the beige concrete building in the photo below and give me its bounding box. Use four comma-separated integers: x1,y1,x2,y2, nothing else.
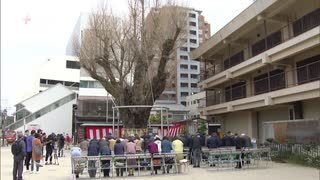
199,8,320,88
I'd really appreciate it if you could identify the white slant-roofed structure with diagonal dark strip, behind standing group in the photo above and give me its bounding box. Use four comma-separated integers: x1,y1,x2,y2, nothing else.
6,84,77,134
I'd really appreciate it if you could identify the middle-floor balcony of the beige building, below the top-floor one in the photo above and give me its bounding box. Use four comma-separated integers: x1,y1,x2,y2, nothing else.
199,59,320,115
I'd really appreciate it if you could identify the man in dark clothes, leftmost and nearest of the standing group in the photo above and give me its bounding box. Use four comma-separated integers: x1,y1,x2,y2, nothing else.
12,133,26,180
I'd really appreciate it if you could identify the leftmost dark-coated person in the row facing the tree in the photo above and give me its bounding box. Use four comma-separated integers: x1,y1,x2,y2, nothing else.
88,139,99,177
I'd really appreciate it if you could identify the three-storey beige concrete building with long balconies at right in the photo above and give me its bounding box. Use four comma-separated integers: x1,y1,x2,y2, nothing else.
191,0,320,142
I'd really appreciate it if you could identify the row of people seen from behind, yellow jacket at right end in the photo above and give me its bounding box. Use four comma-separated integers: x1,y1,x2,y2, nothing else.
71,134,183,177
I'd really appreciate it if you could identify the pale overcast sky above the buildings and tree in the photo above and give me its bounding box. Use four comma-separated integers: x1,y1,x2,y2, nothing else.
1,0,253,111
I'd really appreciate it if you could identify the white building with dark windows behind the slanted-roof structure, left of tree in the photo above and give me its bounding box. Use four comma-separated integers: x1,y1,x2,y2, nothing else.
36,56,80,93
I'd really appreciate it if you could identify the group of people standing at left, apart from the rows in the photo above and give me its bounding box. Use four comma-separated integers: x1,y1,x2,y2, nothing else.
11,129,71,180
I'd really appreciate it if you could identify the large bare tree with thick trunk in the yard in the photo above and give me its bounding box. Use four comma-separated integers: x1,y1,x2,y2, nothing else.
73,0,187,128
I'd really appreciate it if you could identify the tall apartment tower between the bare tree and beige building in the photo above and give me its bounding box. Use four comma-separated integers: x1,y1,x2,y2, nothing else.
176,9,210,106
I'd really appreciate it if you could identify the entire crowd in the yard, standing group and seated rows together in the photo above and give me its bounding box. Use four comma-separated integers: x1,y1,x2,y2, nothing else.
12,129,252,179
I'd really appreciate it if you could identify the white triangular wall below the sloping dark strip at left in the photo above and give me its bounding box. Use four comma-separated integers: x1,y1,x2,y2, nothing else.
17,99,76,134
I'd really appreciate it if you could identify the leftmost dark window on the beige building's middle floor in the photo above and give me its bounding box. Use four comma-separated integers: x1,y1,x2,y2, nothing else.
225,81,246,102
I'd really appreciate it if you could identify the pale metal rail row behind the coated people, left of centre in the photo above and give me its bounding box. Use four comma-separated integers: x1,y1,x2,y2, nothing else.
71,153,188,178
